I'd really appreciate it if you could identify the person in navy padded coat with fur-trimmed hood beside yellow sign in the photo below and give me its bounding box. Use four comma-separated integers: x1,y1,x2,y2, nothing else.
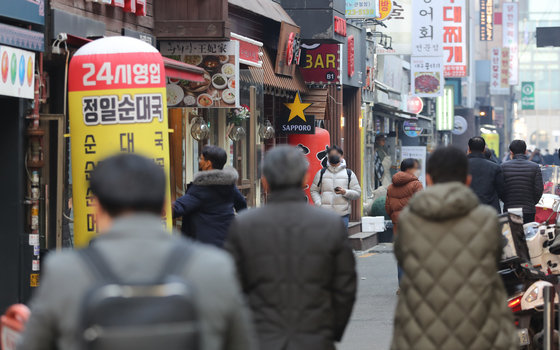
173,146,247,247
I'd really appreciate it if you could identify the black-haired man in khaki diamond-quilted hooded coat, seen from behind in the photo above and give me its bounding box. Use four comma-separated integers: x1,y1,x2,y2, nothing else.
391,147,519,350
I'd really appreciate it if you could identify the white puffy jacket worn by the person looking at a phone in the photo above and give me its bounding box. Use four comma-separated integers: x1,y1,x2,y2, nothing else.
310,159,362,216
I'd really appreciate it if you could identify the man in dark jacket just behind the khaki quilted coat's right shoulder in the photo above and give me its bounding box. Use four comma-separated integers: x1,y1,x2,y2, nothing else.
467,136,505,214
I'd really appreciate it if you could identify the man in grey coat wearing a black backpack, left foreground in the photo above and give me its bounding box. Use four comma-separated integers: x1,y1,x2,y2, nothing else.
18,154,255,350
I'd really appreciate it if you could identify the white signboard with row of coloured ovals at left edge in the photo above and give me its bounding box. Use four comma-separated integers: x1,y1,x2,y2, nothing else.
0,46,35,99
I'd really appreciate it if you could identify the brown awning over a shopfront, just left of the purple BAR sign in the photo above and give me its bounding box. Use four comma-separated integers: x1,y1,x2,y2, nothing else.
241,47,308,95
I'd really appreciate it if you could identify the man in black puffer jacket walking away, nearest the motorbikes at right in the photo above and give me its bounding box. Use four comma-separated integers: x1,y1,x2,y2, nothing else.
502,140,544,223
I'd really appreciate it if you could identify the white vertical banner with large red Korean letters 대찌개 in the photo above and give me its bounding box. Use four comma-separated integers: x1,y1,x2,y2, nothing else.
443,0,469,78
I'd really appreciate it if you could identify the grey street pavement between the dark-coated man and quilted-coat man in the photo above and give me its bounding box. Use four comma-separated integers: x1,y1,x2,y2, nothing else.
338,244,397,350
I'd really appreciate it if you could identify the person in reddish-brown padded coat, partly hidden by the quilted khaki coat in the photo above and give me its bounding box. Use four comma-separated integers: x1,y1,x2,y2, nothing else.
385,158,423,286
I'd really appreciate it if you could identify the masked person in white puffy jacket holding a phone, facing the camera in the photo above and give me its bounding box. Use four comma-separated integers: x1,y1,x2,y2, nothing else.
310,146,362,227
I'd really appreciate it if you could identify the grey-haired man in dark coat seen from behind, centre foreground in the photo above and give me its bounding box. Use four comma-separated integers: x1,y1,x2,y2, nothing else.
225,146,356,350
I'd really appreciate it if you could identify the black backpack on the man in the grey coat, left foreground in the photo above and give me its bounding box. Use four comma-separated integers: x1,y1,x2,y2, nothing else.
78,244,200,350
